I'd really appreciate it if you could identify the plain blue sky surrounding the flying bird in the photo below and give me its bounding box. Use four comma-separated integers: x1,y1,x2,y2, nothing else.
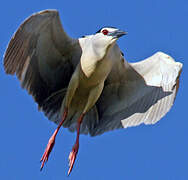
0,0,188,180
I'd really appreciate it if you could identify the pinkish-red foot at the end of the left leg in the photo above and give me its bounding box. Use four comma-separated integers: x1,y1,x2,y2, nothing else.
40,134,55,171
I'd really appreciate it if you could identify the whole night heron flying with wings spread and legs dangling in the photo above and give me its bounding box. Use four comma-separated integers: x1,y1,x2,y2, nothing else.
4,10,182,174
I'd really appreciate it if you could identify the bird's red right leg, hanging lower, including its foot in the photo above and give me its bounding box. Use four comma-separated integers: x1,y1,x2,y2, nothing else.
68,114,84,175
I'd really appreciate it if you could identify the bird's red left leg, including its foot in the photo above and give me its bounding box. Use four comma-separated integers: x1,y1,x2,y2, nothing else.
40,108,68,170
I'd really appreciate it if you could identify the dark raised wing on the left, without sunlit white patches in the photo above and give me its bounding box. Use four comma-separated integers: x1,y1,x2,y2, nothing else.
4,10,81,111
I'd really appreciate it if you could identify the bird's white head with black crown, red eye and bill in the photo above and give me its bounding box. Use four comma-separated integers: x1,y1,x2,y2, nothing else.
92,27,127,57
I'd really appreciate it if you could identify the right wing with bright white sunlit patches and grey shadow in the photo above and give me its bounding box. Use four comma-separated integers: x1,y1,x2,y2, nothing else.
90,52,182,136
